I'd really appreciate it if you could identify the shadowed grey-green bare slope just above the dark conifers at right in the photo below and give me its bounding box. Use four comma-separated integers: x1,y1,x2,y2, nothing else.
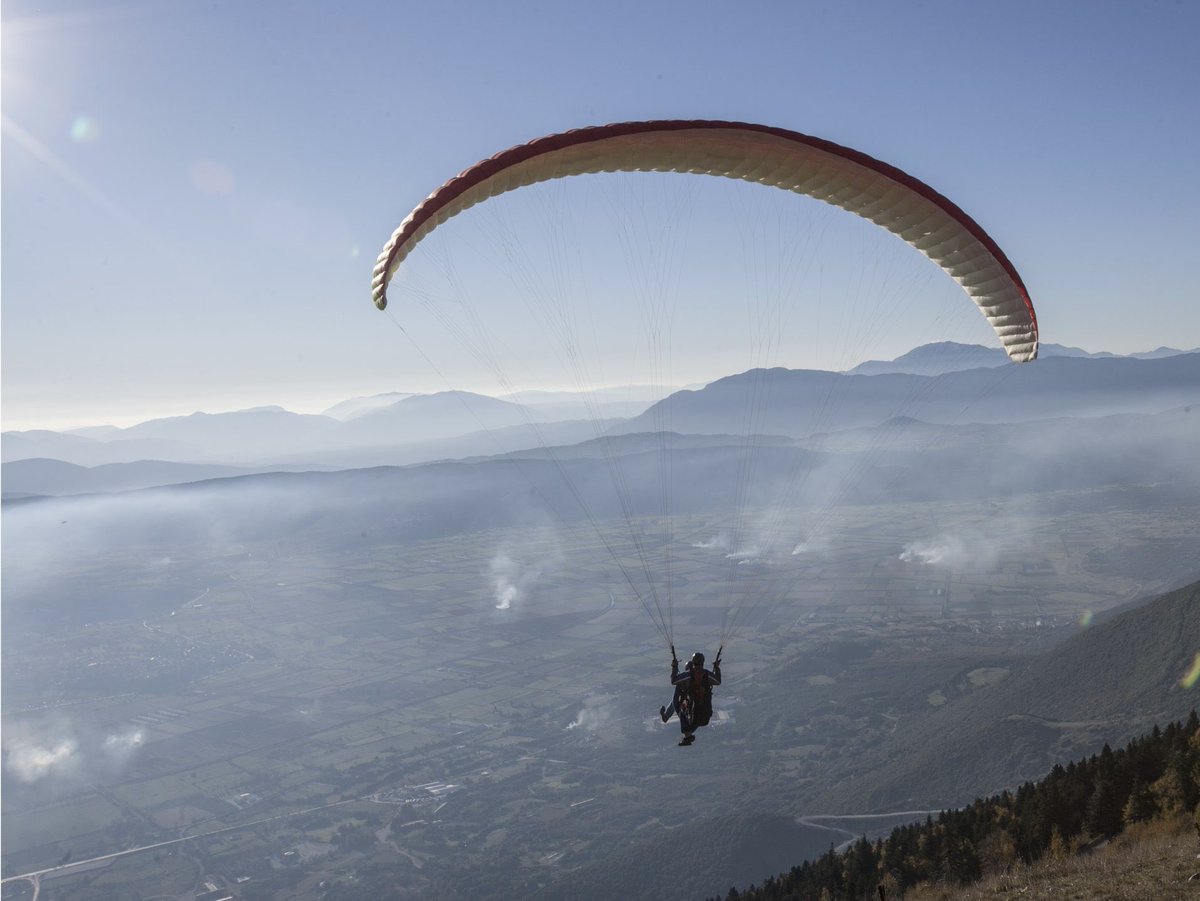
816,582,1200,810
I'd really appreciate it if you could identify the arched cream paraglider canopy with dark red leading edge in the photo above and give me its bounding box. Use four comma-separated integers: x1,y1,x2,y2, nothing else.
372,120,1038,362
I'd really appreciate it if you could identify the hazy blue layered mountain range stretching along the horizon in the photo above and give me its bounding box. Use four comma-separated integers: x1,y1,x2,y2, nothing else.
2,343,1200,479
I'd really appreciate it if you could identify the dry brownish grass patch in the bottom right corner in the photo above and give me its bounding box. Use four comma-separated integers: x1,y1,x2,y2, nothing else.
905,818,1200,901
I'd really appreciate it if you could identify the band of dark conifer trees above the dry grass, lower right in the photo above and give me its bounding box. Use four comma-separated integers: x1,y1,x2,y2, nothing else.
710,710,1200,901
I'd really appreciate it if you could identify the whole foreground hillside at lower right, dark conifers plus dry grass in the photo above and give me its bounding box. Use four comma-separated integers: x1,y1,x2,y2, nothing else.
725,710,1200,901
